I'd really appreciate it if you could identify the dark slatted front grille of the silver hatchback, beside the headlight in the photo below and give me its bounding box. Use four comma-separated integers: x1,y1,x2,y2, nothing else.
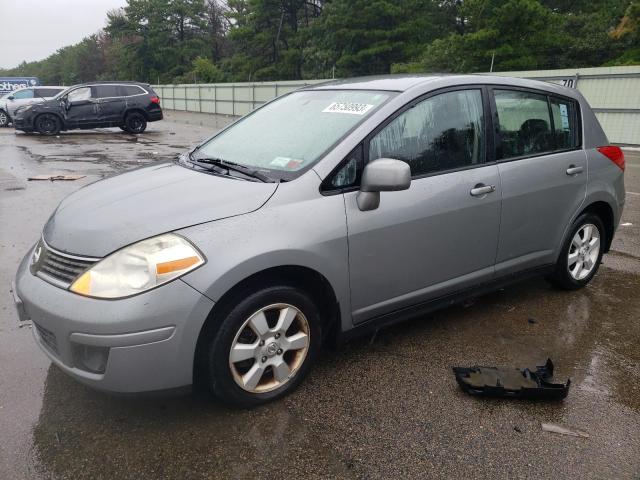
32,240,98,288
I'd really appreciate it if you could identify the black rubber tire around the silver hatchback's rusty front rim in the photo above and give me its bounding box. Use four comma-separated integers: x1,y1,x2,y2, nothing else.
198,285,322,408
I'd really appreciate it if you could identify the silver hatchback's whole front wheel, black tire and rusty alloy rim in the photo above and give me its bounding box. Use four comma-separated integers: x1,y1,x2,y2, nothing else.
202,285,321,407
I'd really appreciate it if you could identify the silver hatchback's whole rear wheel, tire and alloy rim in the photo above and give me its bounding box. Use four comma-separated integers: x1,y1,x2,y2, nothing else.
550,213,606,290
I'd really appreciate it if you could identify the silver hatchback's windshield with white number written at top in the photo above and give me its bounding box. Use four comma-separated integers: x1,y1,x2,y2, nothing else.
194,90,394,180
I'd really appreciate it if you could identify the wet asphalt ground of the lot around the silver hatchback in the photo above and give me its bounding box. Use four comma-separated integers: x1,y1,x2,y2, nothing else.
0,113,640,480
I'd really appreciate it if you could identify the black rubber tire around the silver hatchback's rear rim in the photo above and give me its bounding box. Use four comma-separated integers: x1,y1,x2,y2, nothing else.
549,212,607,290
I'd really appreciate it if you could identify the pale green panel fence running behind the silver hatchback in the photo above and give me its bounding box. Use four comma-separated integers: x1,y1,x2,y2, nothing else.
154,67,640,145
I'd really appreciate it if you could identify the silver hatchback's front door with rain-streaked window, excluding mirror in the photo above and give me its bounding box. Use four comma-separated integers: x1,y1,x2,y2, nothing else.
345,88,501,323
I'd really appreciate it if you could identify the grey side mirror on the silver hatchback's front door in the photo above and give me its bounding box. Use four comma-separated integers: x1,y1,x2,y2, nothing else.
356,158,411,212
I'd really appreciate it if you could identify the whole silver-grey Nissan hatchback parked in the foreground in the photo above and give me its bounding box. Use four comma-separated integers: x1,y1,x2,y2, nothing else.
14,76,624,406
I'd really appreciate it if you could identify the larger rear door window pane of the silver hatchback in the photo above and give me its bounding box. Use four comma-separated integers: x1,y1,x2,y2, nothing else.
494,90,555,159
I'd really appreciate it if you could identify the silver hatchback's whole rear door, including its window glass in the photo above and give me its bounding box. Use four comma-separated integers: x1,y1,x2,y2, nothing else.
492,87,587,275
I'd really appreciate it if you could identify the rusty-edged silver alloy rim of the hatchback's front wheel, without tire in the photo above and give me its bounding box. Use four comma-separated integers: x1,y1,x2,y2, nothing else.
229,303,310,393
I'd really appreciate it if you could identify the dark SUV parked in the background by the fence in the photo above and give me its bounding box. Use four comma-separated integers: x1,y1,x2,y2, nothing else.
13,82,162,135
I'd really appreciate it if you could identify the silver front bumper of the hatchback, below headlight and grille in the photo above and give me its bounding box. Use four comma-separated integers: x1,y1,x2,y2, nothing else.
13,252,213,392
